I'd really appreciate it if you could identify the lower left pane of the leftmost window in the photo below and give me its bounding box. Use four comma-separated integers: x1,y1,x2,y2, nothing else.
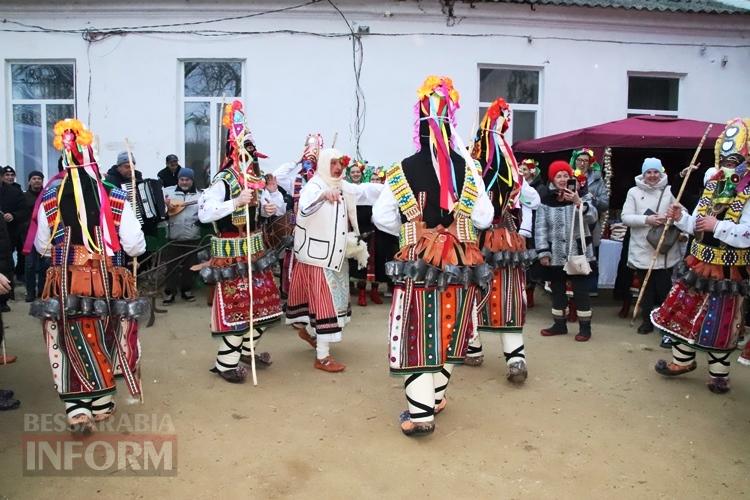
13,104,43,182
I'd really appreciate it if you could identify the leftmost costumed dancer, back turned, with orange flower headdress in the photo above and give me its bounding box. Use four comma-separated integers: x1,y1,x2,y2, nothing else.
27,119,149,434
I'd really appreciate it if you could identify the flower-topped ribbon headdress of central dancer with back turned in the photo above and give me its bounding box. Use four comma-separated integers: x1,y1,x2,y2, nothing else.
414,76,460,211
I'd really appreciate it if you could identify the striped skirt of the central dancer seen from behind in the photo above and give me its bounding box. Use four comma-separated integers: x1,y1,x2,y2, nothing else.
388,282,477,375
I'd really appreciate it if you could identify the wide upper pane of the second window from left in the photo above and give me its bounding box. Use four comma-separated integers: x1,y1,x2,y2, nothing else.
185,62,242,97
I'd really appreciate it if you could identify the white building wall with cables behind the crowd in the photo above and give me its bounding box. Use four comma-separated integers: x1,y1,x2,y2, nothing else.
0,1,750,180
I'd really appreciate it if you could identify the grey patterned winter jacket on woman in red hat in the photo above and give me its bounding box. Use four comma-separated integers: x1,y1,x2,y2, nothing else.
534,185,598,266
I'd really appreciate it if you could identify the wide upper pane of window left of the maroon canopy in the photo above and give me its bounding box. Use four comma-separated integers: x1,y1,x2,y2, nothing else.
479,68,539,104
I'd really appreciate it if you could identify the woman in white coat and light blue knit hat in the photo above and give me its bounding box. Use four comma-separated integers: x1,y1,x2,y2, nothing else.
622,158,682,334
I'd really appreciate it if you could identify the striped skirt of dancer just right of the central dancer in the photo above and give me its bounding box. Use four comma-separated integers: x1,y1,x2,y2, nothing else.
479,266,526,333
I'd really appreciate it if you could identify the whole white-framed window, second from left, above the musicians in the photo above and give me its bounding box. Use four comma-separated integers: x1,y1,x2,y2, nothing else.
183,61,242,189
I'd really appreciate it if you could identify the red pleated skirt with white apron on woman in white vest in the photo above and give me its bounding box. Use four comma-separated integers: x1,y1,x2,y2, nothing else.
286,260,352,342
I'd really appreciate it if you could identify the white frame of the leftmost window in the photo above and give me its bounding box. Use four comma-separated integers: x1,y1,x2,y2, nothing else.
5,58,78,180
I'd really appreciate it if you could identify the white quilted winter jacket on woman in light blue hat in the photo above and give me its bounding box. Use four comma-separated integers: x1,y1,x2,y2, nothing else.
622,175,682,269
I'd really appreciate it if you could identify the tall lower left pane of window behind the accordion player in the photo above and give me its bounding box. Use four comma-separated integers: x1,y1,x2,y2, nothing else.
185,102,211,189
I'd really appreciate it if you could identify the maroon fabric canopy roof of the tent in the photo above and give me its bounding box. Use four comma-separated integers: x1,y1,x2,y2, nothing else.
513,116,724,155
